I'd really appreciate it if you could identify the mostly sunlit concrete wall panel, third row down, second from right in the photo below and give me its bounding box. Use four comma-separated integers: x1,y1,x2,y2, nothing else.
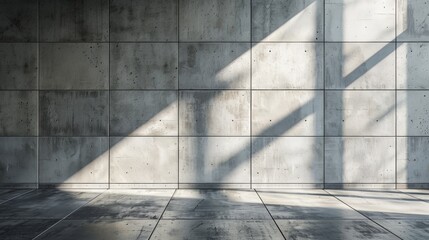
325,91,395,136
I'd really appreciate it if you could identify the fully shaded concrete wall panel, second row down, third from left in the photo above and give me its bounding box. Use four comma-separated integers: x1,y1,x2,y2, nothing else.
110,43,178,90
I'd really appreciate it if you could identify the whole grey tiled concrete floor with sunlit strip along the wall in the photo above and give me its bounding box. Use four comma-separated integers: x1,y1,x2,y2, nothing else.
0,189,429,240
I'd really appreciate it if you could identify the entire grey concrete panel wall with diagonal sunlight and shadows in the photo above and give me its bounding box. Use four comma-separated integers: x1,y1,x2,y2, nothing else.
0,0,429,188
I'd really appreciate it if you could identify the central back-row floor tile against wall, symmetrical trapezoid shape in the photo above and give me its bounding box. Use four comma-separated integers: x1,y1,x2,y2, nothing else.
163,189,271,220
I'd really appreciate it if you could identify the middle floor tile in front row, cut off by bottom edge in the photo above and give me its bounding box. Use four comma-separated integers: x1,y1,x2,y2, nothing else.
151,220,283,240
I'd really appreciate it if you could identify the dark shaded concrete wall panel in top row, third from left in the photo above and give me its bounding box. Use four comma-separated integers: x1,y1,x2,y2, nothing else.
110,0,179,41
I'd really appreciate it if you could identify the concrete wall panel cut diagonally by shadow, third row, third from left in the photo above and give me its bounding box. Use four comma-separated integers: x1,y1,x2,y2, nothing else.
110,91,178,136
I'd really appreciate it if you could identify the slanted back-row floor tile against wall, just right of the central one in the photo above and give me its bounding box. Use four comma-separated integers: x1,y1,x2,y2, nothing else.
258,190,365,219
